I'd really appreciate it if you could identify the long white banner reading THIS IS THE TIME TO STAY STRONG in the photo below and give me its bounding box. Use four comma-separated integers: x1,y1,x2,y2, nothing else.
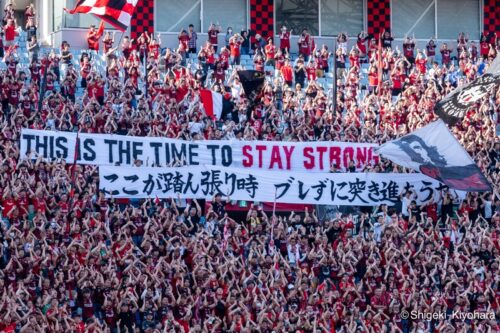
20,129,379,172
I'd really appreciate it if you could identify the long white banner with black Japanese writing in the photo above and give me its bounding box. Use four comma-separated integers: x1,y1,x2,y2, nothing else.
99,166,446,206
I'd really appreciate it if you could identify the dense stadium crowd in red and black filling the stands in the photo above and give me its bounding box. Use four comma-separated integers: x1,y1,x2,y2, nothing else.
0,2,500,333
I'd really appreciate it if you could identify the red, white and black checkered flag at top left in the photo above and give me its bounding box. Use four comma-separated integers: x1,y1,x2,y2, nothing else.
64,0,139,31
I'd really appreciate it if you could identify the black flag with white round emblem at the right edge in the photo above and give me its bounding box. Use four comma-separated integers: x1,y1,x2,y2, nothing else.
434,57,500,126
